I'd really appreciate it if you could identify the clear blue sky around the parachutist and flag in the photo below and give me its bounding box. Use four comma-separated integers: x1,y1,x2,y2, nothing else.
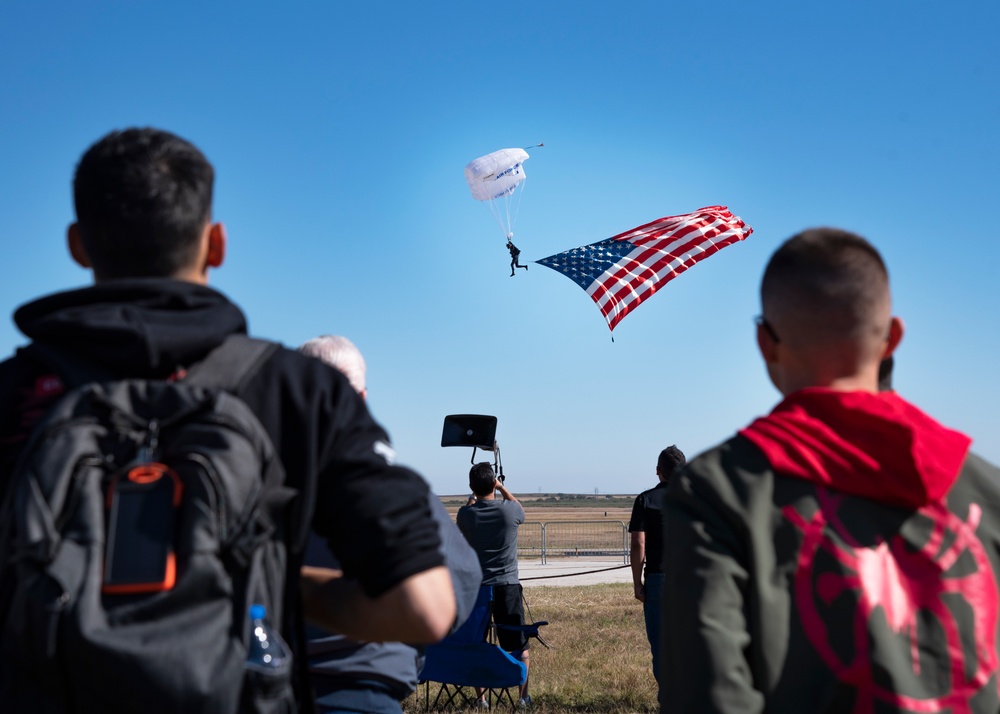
0,0,1000,494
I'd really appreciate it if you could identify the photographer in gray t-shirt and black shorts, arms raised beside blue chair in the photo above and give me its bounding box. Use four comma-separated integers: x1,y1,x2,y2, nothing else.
456,461,531,708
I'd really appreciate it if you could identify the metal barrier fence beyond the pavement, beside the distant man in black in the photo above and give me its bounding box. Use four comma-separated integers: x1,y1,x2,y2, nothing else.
517,521,629,564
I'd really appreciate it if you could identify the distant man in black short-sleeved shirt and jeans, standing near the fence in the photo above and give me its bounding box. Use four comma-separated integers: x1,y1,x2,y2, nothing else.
628,446,686,682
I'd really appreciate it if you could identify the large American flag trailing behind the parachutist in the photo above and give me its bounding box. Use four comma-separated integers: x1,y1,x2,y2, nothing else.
535,206,753,330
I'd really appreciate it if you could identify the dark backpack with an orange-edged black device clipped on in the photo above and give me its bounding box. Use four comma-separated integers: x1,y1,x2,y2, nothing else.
0,335,295,714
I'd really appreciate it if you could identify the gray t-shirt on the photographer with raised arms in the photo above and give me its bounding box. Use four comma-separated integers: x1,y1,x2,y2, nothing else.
455,499,524,585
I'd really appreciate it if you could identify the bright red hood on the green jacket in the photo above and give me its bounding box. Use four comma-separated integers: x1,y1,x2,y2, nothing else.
740,387,972,508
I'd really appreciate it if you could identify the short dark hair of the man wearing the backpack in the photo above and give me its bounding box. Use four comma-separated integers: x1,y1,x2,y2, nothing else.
73,128,215,279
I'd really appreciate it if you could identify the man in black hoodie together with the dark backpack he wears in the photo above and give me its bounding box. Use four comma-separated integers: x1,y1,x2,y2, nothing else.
0,129,455,712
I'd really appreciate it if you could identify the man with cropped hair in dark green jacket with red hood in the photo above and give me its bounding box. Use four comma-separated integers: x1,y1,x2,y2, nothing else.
660,228,1000,714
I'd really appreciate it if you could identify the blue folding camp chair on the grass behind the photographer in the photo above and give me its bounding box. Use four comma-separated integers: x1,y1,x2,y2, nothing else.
420,585,548,709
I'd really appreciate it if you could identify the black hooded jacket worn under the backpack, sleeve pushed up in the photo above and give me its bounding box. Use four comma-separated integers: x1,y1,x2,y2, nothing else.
0,279,443,596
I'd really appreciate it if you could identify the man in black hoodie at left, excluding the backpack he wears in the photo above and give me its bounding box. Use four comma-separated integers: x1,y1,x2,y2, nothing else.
0,129,456,702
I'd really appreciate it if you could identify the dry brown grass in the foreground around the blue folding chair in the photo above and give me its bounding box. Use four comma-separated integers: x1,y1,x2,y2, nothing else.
404,583,659,714
